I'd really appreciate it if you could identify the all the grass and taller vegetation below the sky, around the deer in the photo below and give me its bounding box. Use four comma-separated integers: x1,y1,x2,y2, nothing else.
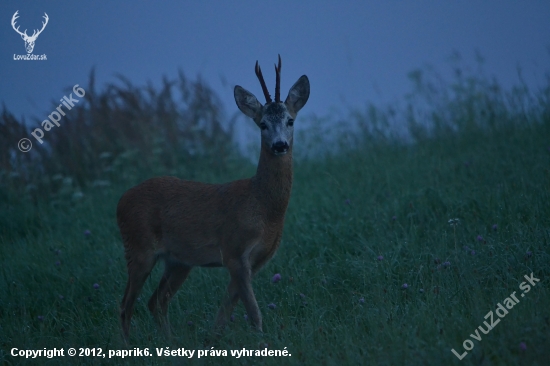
0,59,550,365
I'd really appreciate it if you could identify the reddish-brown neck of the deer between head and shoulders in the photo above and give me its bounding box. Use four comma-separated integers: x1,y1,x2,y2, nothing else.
252,145,292,221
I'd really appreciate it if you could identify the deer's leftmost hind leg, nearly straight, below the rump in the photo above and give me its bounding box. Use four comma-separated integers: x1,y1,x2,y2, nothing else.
120,245,156,342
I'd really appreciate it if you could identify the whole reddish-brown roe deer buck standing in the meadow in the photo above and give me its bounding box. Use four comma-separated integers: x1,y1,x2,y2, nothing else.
117,56,309,340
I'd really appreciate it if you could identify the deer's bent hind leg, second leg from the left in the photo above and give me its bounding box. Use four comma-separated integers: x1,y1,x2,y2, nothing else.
149,260,192,337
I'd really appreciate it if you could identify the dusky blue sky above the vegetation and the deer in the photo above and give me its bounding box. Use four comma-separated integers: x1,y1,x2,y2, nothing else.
0,0,550,124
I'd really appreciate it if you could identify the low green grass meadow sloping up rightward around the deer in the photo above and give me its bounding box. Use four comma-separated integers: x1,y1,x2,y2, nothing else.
0,65,550,365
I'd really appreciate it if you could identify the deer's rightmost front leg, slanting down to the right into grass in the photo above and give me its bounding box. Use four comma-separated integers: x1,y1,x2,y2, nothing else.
228,258,262,332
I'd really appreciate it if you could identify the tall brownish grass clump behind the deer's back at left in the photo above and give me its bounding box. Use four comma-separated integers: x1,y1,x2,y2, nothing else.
0,70,242,200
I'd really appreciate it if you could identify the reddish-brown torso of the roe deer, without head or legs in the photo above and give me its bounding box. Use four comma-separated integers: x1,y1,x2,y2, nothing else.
118,147,292,267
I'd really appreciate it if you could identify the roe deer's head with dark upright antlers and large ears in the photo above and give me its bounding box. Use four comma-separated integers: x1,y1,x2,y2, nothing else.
234,56,309,155
